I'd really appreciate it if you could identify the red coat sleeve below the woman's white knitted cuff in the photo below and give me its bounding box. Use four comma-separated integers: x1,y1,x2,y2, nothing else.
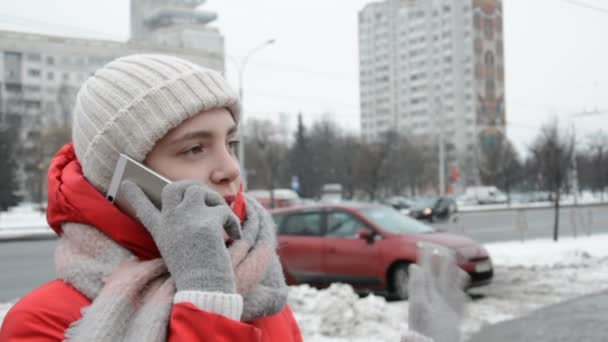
168,303,262,342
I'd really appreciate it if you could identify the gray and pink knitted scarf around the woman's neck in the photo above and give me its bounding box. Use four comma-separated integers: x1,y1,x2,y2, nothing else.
55,197,287,342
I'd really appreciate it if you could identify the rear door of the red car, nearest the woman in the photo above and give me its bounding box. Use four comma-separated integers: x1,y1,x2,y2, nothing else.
275,210,324,284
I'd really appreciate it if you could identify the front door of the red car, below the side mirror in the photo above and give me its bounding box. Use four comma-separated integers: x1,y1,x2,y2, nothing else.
323,210,385,287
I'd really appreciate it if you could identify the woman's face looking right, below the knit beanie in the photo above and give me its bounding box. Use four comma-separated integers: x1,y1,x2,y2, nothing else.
144,108,241,204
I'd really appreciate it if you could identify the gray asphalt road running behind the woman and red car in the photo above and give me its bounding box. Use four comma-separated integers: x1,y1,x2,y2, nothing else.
0,205,608,302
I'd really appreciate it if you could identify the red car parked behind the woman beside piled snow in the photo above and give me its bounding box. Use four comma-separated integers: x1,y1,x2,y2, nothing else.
272,203,493,299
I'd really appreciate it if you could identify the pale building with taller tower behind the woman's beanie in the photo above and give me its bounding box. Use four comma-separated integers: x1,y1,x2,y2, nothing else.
0,0,224,201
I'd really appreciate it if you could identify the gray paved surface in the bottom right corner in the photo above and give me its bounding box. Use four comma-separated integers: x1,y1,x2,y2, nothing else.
468,292,608,342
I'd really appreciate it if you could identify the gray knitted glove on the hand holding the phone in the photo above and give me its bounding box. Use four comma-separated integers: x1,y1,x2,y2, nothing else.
121,180,241,293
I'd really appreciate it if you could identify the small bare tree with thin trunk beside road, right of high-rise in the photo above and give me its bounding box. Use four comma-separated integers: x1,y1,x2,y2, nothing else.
530,120,575,241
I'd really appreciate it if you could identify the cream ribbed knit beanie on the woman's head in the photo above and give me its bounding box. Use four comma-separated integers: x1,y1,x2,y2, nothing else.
72,55,240,194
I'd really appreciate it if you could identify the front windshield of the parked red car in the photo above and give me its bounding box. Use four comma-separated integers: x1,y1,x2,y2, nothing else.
361,207,435,234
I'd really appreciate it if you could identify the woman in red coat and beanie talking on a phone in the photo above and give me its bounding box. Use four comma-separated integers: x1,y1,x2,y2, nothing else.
0,55,301,342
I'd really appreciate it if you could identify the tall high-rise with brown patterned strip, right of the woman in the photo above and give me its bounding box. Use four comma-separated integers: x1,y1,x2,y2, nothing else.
359,0,506,185
